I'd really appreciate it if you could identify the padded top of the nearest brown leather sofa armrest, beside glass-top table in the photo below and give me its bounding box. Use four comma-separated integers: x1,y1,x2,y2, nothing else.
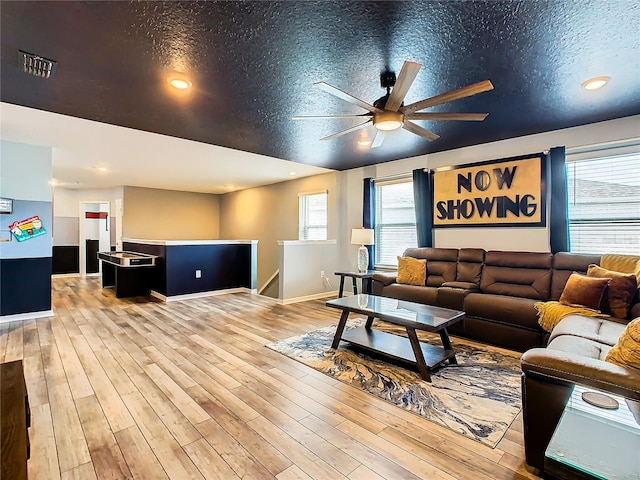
520,348,640,400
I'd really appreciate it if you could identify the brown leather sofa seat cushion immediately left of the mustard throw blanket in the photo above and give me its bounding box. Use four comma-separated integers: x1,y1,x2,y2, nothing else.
463,293,539,330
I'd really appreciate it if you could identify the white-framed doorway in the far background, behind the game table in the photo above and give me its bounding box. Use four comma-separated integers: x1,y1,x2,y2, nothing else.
78,201,111,277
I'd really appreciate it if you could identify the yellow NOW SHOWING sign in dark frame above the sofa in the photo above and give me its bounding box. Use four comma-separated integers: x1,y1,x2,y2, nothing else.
433,154,547,227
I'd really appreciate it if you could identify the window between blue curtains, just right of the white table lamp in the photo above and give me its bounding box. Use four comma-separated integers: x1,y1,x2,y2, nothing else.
374,178,418,266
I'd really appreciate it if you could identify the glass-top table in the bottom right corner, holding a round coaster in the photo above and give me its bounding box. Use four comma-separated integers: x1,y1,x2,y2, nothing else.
545,385,640,480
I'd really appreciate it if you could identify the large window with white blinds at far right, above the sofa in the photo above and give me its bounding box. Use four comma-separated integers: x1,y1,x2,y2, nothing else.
567,154,640,255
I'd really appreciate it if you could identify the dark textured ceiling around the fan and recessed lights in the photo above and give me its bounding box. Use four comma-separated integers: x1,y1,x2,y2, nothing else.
0,0,640,169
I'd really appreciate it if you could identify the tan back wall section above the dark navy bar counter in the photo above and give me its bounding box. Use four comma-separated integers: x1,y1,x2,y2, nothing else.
122,187,220,240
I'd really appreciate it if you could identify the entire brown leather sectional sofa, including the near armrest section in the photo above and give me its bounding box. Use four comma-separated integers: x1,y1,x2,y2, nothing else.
373,248,640,470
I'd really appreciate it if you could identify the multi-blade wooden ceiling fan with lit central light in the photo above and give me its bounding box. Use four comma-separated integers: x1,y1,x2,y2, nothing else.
293,61,493,148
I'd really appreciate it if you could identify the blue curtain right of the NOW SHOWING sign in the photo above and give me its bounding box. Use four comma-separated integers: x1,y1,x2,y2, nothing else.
549,147,569,253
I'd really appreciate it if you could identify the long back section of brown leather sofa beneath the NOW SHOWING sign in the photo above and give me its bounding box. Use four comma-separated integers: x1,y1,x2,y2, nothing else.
373,247,640,352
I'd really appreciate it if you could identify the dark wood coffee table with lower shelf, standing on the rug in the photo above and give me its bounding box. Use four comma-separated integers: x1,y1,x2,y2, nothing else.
326,294,464,382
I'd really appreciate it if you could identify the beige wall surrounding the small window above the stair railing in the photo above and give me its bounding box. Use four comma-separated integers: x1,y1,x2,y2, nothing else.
220,173,338,288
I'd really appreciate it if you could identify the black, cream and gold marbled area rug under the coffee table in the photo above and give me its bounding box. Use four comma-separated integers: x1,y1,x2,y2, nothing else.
267,319,521,448
